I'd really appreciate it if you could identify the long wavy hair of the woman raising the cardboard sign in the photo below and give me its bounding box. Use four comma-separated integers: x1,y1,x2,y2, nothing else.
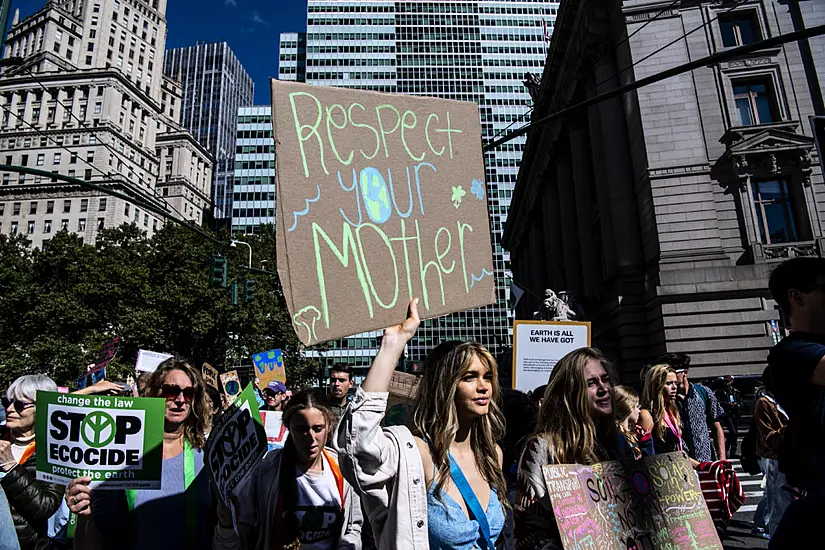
411,341,507,502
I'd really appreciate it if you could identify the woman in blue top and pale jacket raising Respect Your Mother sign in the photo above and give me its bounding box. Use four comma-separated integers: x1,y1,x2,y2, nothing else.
335,299,507,550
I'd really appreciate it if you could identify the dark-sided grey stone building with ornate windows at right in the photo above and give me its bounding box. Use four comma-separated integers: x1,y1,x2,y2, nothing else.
503,0,825,382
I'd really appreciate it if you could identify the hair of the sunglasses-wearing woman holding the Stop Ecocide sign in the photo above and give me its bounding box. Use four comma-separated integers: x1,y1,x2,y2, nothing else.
143,358,212,449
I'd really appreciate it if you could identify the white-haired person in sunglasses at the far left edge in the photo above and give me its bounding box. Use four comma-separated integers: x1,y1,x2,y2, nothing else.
0,374,63,550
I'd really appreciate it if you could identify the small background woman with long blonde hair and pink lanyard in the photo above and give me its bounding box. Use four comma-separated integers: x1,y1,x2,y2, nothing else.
639,364,683,454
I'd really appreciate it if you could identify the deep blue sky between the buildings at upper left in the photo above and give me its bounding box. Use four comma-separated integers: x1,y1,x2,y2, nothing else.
5,0,306,104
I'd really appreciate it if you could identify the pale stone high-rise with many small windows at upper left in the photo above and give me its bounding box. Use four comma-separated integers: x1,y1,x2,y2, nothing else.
0,0,213,246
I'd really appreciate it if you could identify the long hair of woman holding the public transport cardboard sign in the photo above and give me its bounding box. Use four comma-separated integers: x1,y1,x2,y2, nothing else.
536,348,616,464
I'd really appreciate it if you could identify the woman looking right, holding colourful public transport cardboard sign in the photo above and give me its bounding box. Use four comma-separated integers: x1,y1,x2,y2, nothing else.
514,348,629,550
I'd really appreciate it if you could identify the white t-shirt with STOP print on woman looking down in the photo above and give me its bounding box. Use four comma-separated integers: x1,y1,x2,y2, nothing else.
295,460,344,550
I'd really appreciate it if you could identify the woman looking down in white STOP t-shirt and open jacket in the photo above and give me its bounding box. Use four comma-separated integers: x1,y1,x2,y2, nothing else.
214,390,361,550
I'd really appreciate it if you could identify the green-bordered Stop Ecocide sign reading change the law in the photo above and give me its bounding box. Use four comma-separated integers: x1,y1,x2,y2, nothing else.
35,391,165,489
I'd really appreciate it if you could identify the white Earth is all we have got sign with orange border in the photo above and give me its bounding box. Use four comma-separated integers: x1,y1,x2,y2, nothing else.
513,321,590,392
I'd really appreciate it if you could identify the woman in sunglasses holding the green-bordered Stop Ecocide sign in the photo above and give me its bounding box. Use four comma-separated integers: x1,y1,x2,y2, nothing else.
66,359,216,550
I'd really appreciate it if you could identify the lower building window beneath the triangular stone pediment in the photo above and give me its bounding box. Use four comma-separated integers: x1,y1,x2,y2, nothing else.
751,179,799,244
